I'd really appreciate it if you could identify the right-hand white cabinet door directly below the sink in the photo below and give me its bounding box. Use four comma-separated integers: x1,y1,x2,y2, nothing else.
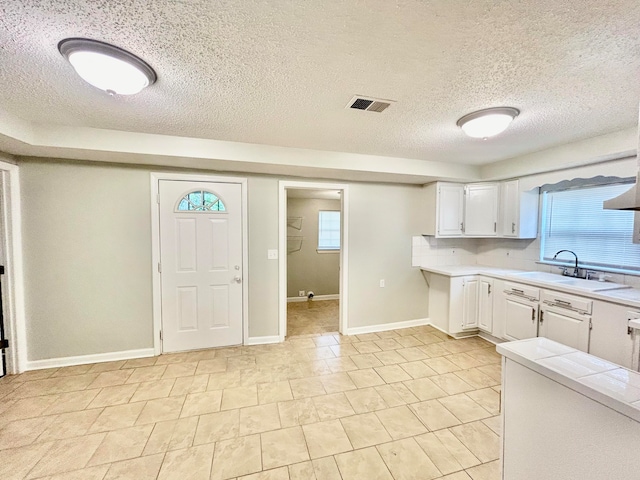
538,308,591,352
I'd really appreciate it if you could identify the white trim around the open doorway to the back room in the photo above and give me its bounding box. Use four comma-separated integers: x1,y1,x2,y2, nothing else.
278,180,349,342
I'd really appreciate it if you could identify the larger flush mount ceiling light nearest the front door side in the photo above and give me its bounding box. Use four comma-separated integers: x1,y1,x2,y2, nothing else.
58,38,157,95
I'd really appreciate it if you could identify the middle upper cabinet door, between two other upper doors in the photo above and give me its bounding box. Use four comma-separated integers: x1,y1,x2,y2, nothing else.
464,183,499,237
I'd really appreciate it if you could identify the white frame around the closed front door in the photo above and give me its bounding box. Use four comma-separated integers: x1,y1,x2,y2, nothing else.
150,172,249,355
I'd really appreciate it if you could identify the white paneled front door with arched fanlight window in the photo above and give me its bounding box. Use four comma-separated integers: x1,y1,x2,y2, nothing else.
159,180,243,352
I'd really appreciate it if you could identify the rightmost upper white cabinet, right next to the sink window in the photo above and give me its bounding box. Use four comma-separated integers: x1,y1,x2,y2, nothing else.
500,180,539,238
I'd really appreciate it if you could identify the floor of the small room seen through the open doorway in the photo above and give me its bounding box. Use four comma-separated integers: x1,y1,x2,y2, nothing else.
287,300,340,336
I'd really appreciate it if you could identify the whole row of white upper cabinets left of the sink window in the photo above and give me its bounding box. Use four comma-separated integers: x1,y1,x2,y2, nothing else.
424,180,538,238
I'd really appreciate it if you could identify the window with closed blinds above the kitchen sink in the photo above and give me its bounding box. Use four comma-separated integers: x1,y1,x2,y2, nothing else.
540,183,640,271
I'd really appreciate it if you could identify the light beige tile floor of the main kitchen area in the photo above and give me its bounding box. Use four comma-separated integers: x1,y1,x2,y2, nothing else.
0,327,500,480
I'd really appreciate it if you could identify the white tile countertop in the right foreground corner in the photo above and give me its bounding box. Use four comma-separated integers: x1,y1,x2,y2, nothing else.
496,337,640,422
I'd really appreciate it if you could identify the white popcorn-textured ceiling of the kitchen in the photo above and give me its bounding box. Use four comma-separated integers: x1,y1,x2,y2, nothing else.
0,0,640,164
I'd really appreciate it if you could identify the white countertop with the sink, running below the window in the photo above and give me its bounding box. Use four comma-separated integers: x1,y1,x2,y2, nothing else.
420,265,640,308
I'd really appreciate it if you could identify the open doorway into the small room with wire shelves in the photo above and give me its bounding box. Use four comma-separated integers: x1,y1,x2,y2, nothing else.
280,182,348,340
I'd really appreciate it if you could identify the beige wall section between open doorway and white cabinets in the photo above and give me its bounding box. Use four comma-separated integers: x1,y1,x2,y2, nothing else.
348,183,428,327
